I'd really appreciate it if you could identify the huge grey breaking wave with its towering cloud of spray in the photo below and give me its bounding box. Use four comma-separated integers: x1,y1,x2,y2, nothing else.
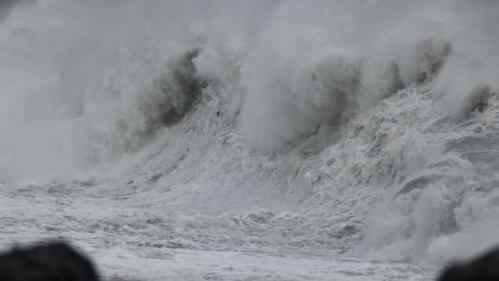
0,0,499,261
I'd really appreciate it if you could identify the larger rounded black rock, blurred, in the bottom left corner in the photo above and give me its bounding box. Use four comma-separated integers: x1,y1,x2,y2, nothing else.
0,238,99,281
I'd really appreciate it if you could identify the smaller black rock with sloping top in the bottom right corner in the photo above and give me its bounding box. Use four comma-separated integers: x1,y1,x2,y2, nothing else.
438,245,499,281
